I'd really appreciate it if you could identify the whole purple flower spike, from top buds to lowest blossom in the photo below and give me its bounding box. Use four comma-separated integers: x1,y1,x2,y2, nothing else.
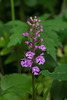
21,16,46,75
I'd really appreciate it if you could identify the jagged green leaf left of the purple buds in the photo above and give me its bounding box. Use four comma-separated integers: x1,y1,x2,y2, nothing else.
6,21,28,47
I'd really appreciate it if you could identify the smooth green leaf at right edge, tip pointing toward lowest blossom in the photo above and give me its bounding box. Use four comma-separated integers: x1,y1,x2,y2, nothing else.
41,64,67,80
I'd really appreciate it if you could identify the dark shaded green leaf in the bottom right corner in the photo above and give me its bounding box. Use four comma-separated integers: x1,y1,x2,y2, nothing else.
51,80,67,100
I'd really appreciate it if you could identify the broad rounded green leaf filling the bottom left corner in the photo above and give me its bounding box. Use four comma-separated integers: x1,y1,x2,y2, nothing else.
1,74,32,95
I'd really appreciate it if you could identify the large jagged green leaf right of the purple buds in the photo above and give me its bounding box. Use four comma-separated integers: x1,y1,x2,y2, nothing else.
40,15,67,60
